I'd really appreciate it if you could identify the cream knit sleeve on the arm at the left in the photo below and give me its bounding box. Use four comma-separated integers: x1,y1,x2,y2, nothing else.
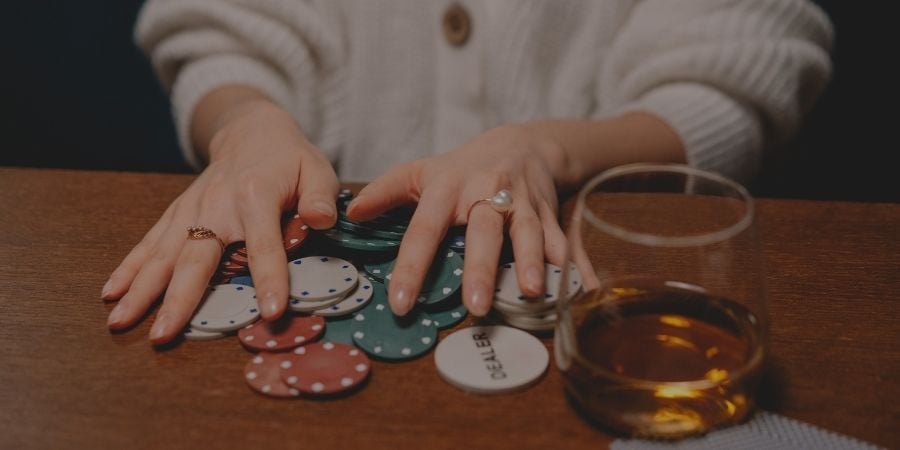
135,0,342,169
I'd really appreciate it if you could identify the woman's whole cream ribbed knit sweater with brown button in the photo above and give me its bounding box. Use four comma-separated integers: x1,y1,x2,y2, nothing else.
136,0,832,181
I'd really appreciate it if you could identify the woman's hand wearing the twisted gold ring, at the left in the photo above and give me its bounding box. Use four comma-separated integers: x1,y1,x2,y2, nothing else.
101,92,340,344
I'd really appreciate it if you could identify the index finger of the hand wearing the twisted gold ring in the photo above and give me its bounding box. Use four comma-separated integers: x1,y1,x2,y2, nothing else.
241,193,290,320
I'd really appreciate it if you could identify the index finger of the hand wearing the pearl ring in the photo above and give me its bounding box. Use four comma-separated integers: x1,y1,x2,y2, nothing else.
388,185,456,316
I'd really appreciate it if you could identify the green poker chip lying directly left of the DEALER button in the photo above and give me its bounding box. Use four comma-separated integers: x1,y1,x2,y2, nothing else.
353,299,438,361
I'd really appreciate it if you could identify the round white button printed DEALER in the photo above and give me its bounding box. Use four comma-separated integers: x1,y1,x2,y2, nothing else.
434,326,550,394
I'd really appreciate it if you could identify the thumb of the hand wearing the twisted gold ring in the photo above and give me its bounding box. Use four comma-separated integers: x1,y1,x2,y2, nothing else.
297,154,341,230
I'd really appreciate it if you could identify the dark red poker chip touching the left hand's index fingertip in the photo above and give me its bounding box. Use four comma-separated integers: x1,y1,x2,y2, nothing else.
238,314,325,352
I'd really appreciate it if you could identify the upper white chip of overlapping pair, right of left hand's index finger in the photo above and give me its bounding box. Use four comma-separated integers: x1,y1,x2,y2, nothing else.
288,256,359,301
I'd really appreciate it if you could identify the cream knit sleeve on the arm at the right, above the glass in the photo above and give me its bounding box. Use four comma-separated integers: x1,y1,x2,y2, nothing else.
598,0,832,182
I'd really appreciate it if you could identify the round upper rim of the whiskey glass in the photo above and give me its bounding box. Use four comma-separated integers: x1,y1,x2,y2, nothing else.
573,163,755,247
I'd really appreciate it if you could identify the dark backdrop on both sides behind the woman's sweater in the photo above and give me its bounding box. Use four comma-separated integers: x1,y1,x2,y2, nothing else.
0,0,900,202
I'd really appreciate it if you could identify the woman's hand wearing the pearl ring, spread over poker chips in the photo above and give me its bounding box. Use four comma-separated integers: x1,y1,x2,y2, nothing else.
347,125,567,316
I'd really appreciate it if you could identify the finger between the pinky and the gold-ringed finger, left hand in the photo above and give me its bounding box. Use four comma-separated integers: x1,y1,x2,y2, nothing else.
106,214,195,330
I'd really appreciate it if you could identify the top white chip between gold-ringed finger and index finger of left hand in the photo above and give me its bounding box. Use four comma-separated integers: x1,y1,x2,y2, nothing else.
191,284,259,333
